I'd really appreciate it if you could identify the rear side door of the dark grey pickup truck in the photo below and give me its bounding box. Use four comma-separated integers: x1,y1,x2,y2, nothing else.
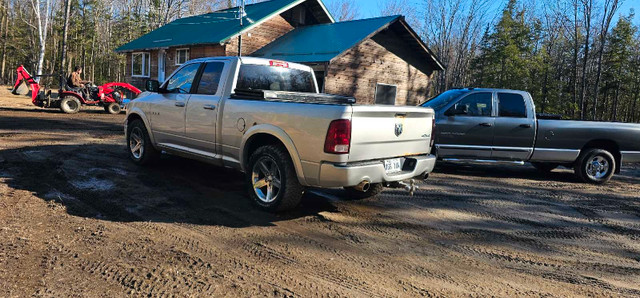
491,92,536,161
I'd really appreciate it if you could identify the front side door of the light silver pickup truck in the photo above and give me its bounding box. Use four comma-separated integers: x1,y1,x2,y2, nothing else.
150,63,201,146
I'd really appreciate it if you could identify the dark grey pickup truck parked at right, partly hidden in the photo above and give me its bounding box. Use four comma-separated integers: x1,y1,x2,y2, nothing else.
422,88,640,184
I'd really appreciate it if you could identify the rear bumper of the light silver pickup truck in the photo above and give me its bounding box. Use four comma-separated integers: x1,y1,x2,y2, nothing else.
318,155,436,187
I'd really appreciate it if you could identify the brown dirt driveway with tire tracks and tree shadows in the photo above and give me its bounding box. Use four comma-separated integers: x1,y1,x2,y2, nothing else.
0,88,640,297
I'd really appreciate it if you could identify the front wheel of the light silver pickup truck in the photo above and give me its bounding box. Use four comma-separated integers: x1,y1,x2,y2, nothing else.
127,119,161,166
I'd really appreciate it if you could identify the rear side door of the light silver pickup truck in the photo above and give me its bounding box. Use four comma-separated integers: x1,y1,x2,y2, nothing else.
186,61,229,155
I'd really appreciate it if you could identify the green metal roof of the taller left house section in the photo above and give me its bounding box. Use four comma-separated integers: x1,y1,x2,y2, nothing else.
116,0,333,52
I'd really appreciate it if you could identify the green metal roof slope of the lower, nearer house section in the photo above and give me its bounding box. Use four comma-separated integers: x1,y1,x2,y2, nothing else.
252,16,401,63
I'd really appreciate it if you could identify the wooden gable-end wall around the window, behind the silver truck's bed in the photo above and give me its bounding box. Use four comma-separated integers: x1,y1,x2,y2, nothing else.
325,39,432,105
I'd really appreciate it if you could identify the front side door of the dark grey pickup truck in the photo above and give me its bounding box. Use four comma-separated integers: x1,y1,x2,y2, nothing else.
436,92,495,159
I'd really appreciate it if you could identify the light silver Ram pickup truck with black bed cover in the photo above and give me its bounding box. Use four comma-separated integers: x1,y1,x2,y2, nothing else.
125,57,436,211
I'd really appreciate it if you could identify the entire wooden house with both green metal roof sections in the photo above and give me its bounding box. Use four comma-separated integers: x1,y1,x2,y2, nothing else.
116,0,444,104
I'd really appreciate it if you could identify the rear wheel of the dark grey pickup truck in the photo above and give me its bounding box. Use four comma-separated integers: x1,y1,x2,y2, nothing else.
574,148,616,184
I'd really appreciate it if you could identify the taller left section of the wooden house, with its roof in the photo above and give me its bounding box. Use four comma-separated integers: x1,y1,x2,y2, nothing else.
116,0,334,87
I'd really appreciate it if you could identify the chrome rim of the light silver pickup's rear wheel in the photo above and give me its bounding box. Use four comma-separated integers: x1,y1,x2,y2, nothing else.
251,156,282,203
